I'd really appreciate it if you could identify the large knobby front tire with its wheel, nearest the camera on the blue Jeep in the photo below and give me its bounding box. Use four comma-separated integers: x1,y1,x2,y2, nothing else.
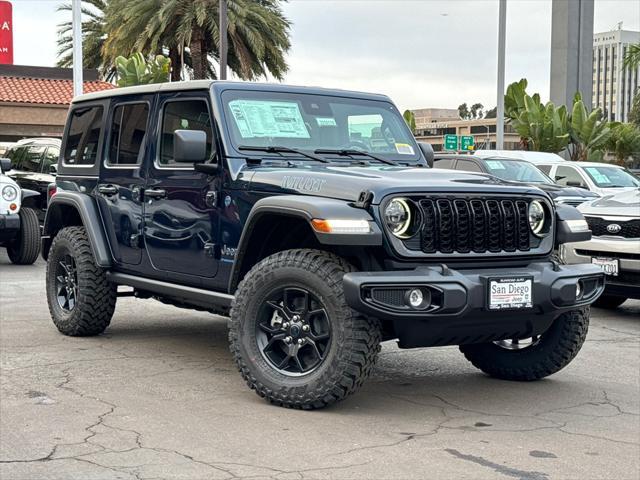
229,249,381,409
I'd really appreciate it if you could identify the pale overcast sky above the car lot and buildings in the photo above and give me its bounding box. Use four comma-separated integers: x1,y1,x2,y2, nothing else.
12,0,640,110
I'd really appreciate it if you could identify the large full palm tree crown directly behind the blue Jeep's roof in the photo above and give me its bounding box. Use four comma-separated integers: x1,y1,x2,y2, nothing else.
103,0,290,80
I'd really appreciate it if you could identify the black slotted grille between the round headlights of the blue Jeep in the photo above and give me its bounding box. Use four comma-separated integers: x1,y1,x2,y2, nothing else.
405,197,531,254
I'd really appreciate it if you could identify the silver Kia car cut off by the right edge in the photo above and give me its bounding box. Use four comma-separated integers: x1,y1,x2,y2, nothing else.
560,188,640,308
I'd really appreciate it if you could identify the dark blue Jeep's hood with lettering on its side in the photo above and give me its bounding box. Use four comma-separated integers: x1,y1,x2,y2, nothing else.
247,165,542,203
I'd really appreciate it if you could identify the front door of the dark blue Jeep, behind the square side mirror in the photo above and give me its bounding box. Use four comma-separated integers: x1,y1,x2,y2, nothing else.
144,91,219,278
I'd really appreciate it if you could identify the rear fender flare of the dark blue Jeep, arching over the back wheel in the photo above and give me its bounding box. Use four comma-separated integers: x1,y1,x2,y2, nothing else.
43,190,112,268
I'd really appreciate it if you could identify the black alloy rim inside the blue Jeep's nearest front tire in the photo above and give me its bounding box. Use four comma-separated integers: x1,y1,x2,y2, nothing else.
256,287,331,376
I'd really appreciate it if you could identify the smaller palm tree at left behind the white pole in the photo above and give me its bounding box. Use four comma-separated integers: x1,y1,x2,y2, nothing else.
57,0,111,76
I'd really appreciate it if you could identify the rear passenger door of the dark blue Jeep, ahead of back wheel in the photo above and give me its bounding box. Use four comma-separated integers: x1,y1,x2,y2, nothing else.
96,95,154,266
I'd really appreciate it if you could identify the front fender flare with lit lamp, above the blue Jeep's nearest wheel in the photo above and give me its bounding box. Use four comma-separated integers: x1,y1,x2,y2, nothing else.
228,195,382,292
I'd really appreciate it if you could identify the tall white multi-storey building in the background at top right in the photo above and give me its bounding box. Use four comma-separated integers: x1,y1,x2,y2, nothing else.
592,23,640,122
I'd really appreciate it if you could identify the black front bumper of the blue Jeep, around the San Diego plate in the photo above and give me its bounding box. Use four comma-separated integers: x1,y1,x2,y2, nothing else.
344,262,604,348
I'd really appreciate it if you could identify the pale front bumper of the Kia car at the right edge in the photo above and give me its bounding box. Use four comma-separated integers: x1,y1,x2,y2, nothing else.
559,236,640,298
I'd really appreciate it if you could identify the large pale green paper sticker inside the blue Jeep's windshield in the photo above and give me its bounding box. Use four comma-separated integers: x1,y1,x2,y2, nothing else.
229,100,310,138
